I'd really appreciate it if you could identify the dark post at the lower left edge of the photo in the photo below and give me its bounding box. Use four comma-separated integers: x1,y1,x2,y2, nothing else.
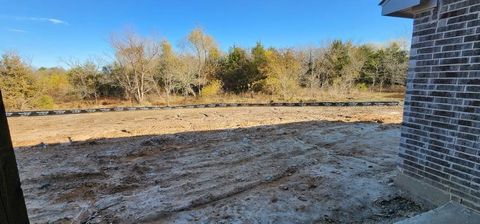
0,91,29,224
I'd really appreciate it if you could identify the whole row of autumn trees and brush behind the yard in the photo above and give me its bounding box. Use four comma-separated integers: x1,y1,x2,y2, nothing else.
0,28,408,109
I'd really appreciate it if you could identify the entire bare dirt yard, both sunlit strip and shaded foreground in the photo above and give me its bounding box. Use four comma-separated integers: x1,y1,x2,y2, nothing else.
9,107,423,223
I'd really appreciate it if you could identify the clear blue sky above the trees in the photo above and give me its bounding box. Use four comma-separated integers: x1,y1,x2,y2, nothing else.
0,0,412,67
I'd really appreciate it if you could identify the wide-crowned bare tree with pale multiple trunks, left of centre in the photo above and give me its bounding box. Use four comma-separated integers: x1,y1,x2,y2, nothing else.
111,32,161,103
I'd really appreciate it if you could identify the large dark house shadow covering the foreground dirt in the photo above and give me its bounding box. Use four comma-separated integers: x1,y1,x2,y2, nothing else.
16,121,423,223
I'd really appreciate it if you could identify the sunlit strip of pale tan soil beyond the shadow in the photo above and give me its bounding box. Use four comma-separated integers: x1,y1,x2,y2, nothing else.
8,107,402,147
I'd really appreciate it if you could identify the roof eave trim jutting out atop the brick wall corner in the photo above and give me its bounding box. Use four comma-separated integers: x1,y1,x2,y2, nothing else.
380,0,438,18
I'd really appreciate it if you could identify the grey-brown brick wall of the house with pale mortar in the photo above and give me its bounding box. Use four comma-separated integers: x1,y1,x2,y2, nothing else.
399,0,480,211
